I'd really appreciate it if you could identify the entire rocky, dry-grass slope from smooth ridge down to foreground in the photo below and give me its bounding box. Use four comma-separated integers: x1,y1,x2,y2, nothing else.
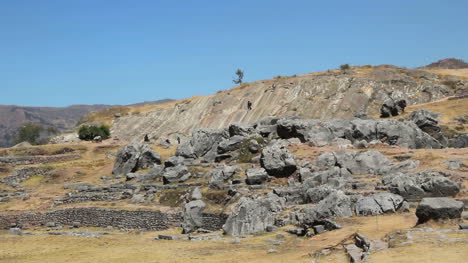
0,62,468,262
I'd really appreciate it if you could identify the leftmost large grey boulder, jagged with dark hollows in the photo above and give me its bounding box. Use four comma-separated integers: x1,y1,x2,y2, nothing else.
112,143,161,175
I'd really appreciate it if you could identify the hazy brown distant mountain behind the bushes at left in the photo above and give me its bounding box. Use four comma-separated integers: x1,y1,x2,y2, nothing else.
0,99,172,147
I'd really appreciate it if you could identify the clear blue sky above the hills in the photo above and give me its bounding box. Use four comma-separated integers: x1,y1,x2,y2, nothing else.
0,0,468,106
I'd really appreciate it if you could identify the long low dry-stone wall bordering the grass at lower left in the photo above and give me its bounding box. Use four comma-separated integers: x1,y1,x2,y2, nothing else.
0,208,227,230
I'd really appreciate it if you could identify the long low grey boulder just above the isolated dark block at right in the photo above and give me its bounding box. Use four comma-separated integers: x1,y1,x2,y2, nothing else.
382,171,460,200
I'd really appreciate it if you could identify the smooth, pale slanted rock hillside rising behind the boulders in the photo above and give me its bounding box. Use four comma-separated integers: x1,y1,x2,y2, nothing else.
90,65,468,144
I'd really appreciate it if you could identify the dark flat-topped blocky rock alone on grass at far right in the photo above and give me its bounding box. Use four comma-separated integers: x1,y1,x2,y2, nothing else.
416,197,463,224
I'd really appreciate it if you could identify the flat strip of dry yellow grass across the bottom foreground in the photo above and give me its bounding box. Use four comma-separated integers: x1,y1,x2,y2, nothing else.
0,214,416,263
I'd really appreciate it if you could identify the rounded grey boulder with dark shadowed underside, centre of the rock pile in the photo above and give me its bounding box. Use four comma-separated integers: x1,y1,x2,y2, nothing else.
260,142,297,177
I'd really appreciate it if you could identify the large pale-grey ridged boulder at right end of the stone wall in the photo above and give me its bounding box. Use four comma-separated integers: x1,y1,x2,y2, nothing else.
223,193,284,236
